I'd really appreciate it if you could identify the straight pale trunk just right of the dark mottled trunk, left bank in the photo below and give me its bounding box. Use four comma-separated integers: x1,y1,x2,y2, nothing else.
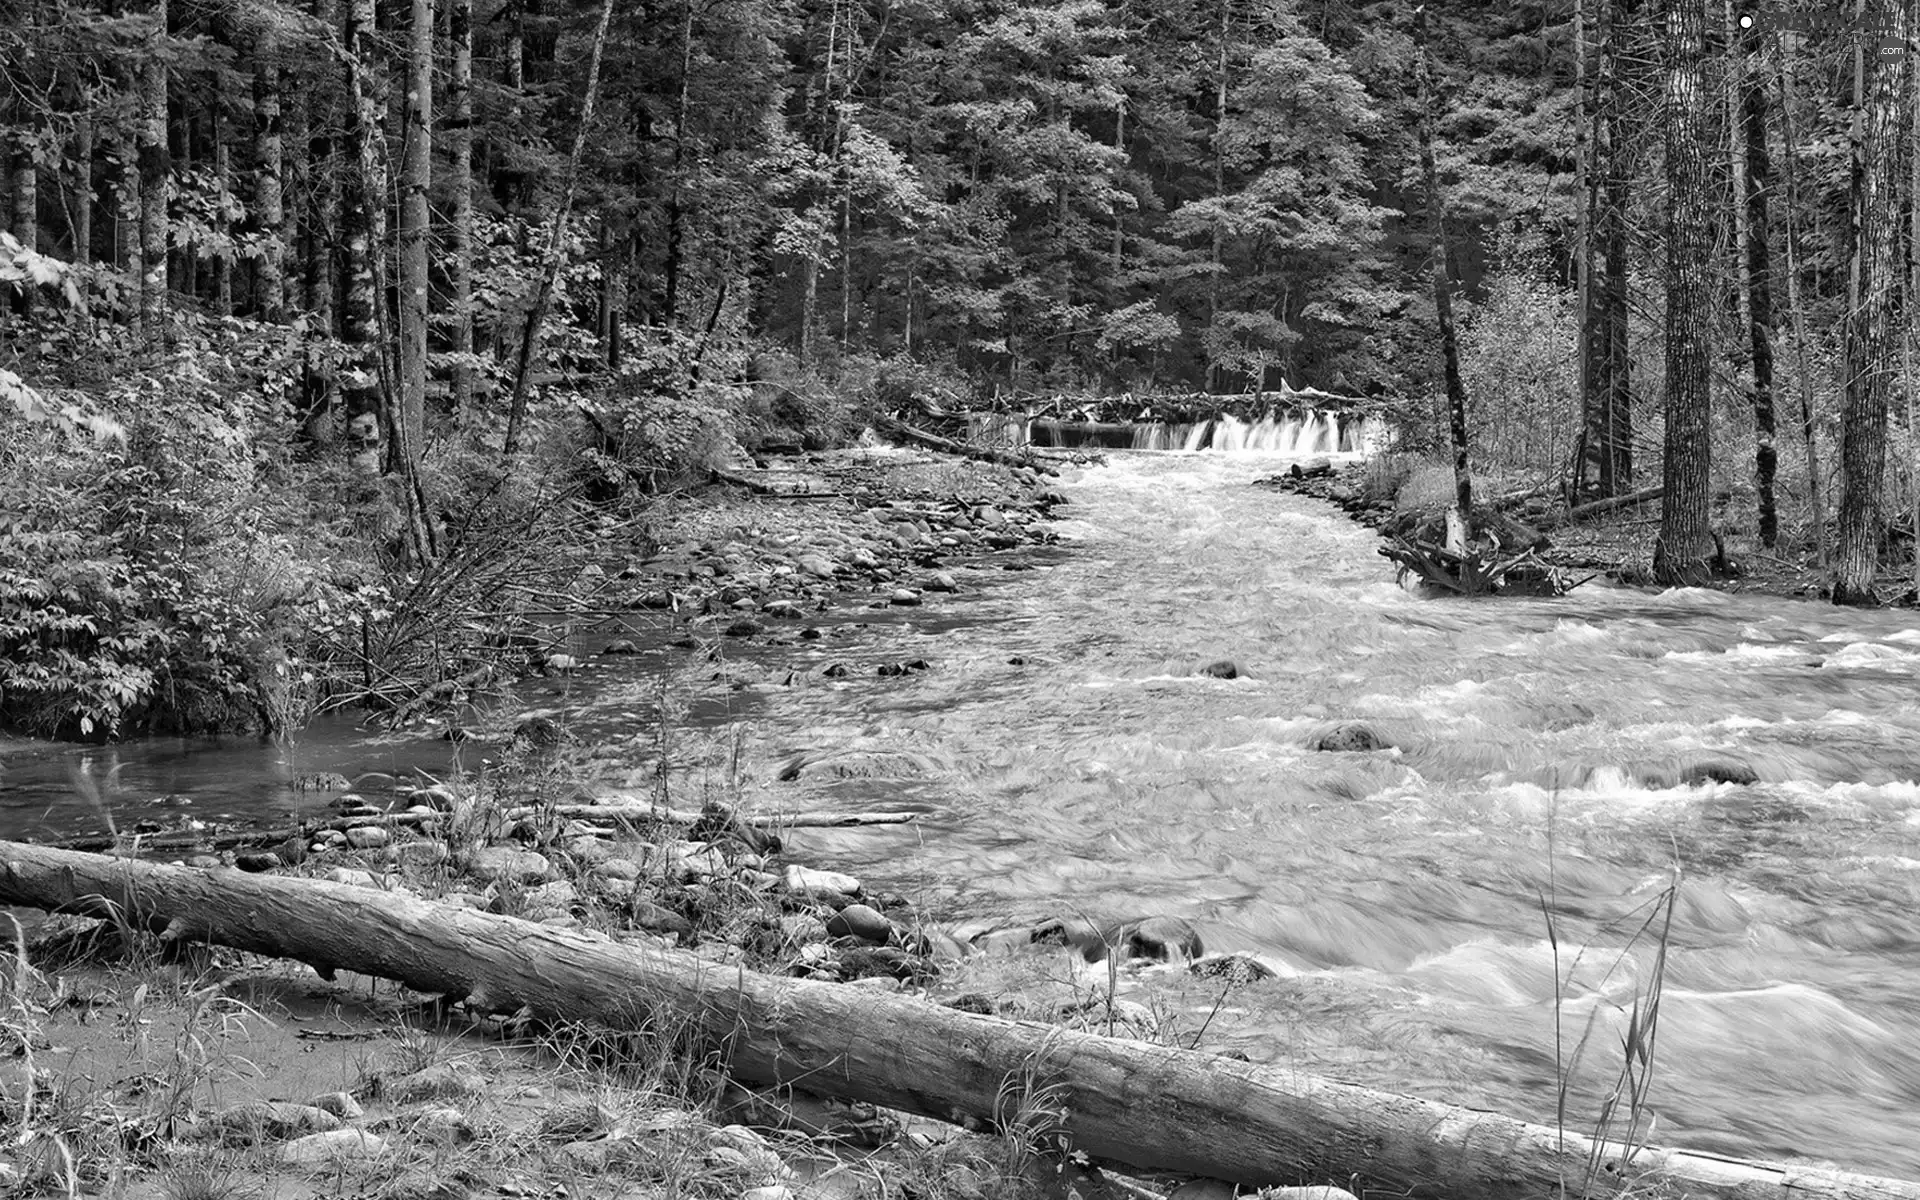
394,0,434,467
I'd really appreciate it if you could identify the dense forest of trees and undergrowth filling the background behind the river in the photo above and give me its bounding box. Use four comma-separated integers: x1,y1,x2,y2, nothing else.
0,0,1920,733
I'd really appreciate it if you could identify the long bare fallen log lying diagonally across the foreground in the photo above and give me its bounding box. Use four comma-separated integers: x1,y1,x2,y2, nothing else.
0,841,1920,1200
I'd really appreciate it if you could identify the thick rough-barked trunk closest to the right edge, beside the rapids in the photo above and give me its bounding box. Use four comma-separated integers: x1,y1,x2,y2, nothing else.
1834,0,1912,605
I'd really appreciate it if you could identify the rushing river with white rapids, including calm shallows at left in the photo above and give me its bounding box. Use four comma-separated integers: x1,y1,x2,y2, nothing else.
0,445,1920,1179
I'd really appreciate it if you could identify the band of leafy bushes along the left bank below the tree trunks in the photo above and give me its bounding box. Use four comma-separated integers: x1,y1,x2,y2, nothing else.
0,270,944,739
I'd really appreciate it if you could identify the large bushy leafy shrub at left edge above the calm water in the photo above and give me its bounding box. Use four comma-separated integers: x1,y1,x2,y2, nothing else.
0,393,341,737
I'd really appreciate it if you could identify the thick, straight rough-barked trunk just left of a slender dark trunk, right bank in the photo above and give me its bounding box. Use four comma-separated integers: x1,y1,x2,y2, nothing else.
1653,0,1715,588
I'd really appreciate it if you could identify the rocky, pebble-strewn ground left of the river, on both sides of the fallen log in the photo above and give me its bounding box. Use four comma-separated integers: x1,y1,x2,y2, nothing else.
0,449,1305,1200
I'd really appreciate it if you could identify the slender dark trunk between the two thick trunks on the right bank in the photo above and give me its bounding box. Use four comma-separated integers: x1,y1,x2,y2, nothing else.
1740,5,1780,549
